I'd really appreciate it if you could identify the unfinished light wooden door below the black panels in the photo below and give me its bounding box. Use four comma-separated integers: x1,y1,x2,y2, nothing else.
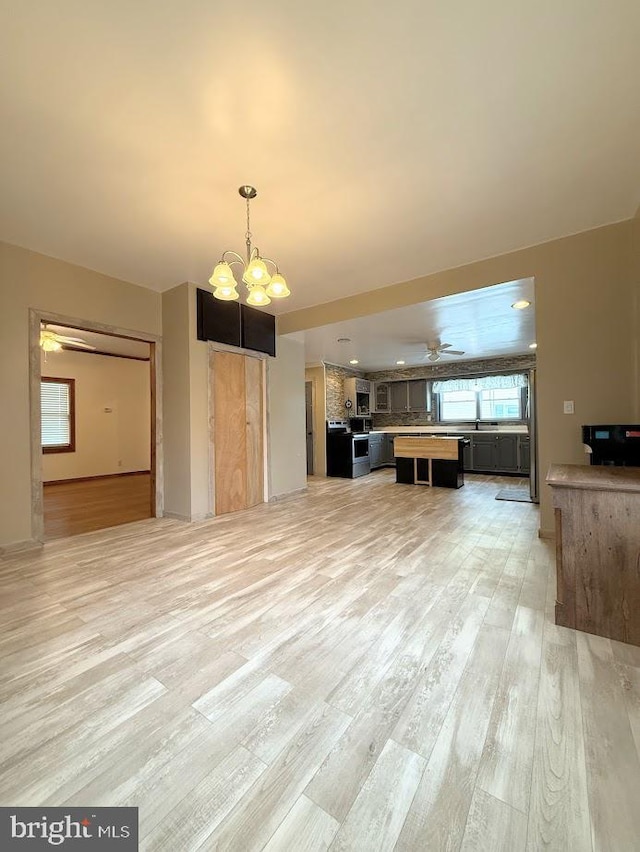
210,352,264,515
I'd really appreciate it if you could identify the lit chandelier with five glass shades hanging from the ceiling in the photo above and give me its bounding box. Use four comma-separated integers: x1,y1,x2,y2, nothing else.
209,186,291,307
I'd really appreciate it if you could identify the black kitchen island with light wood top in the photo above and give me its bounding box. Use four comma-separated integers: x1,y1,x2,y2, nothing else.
393,436,465,488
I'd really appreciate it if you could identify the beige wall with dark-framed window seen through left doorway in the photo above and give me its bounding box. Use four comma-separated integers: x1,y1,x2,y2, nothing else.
41,352,151,482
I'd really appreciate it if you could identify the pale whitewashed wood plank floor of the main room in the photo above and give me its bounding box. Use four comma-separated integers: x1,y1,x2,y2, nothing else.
0,470,640,852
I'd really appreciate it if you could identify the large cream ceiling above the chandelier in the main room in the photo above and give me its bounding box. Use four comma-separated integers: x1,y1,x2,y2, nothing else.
0,0,640,312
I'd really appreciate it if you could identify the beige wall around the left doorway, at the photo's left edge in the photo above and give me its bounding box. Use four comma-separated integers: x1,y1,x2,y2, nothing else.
0,243,161,547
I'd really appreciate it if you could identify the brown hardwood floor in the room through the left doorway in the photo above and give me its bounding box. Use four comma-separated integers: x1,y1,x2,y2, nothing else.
43,473,151,540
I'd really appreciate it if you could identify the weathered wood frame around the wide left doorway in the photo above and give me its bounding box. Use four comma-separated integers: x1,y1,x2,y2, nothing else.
29,308,164,542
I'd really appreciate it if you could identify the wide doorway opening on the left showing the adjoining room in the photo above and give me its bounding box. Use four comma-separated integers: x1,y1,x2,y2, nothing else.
30,311,163,540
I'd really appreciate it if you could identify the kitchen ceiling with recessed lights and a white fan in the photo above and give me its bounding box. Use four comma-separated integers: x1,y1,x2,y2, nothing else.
301,278,536,370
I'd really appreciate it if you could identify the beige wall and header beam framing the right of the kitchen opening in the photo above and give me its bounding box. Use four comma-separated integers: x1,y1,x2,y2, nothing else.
278,221,638,533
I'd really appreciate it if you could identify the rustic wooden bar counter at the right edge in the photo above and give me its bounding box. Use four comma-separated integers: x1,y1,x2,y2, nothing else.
547,465,640,645
